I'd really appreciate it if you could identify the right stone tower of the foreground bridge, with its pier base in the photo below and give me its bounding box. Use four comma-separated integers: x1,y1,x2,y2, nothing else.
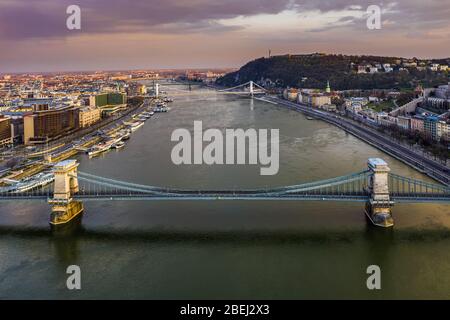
365,158,394,228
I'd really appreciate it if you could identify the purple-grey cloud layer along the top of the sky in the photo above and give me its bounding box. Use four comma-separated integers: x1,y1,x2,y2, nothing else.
0,0,450,40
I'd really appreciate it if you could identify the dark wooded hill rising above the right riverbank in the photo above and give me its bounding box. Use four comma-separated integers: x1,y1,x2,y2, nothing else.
217,54,450,90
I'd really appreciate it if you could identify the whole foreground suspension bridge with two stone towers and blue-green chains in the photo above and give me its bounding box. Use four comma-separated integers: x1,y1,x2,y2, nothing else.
0,158,450,227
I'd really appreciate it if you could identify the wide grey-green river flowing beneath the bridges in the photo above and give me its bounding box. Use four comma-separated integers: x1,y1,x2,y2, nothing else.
0,86,450,299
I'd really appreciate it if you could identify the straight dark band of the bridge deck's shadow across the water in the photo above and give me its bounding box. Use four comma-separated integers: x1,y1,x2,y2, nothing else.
0,218,450,245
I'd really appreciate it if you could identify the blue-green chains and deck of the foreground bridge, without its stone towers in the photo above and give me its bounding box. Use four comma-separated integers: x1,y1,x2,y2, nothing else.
0,170,450,201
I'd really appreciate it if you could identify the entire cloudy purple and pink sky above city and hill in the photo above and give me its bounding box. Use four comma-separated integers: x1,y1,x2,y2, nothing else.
0,0,450,73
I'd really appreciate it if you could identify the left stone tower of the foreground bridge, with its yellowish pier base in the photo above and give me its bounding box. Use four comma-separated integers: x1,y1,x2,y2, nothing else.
48,160,83,225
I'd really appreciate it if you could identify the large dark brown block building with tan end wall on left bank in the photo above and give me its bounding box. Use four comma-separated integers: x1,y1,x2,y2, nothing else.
23,107,79,145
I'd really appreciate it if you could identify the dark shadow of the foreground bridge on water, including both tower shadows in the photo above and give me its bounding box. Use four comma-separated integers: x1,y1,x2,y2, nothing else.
0,219,450,272
